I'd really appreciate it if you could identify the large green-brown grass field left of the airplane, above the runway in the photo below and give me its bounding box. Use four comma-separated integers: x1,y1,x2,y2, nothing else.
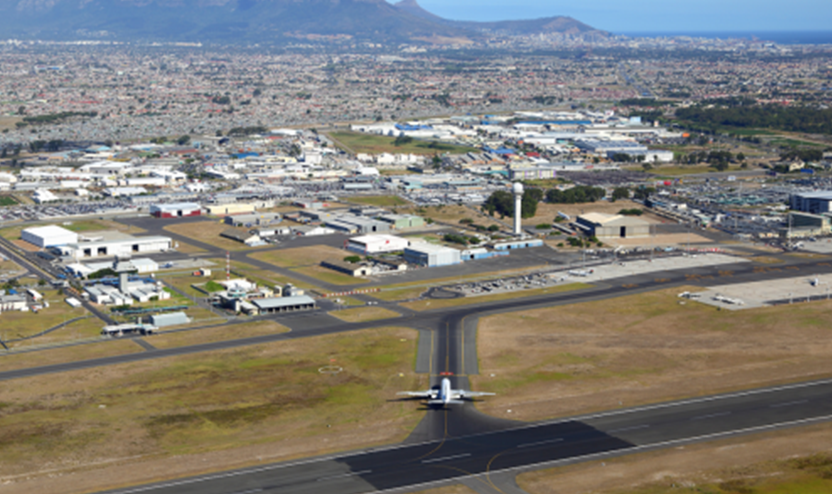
0,328,427,492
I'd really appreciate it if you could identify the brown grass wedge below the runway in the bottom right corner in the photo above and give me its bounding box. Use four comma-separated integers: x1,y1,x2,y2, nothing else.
517,424,832,494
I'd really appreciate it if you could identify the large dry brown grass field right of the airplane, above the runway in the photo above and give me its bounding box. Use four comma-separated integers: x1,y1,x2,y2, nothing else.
473,288,832,420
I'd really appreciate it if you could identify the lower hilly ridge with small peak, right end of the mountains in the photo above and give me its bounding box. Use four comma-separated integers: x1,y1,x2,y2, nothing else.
395,0,607,36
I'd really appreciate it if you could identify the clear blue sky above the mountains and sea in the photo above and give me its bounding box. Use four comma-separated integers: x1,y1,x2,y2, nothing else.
393,0,832,33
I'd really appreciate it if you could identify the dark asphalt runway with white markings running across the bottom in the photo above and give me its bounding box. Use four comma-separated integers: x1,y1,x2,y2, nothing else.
104,381,832,494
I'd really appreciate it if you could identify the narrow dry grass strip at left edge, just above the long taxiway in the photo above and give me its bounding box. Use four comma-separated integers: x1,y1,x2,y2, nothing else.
0,340,141,372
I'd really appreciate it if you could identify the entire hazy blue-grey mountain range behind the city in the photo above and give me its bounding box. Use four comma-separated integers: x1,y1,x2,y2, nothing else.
0,0,597,45
